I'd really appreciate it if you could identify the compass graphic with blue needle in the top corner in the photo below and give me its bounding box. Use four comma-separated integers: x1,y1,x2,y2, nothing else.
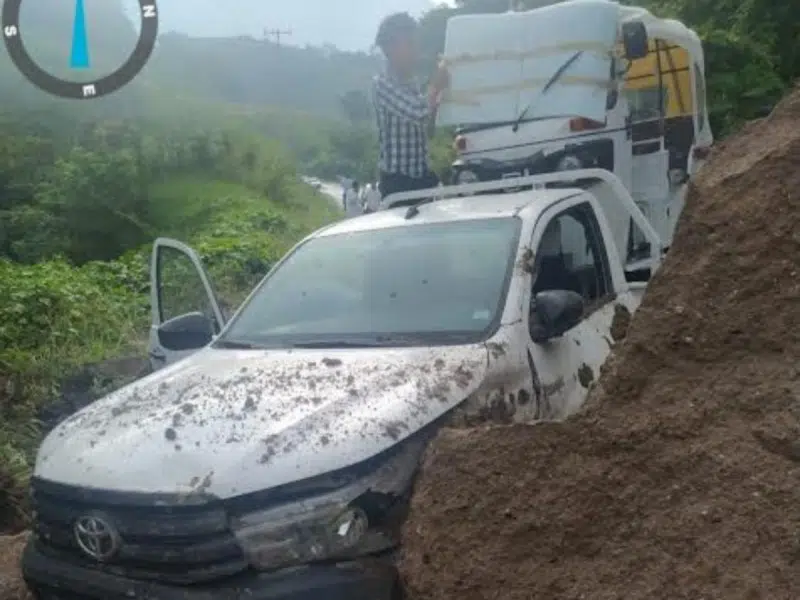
2,0,158,100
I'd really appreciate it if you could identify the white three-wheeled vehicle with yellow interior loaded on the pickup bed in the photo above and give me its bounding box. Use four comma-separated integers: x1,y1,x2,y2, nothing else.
438,0,713,262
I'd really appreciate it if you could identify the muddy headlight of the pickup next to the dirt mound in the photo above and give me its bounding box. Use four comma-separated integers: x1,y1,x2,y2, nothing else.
231,439,427,570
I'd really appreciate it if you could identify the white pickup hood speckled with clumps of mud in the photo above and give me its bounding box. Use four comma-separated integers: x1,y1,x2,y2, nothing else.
35,344,488,498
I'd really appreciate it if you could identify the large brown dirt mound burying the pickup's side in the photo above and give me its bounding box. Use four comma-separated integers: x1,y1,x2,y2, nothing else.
401,85,800,600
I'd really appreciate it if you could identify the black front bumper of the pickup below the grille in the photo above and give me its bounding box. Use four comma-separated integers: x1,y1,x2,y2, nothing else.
22,539,399,600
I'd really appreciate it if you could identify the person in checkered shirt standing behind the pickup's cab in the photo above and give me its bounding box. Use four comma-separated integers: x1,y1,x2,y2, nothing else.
372,13,450,197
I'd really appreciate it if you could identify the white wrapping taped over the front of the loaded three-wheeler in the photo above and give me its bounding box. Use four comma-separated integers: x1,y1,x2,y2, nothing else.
437,0,620,126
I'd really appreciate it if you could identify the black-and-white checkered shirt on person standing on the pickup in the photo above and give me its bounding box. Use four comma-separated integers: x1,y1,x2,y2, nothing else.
372,74,430,178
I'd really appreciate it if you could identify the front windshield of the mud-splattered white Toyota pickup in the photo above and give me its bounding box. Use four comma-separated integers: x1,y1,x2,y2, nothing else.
217,217,520,347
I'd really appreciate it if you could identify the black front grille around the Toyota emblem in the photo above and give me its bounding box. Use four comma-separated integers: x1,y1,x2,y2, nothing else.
32,480,247,585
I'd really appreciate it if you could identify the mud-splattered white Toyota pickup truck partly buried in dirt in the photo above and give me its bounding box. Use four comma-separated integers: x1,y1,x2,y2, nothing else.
22,170,661,600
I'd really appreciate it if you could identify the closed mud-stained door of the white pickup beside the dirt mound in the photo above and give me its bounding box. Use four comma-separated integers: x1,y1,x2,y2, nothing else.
528,195,614,420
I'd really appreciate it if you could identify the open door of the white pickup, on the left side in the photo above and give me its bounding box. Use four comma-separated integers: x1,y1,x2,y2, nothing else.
148,238,225,370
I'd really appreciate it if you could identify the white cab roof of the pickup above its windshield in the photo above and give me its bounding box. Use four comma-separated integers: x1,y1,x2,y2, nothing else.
312,188,583,237
